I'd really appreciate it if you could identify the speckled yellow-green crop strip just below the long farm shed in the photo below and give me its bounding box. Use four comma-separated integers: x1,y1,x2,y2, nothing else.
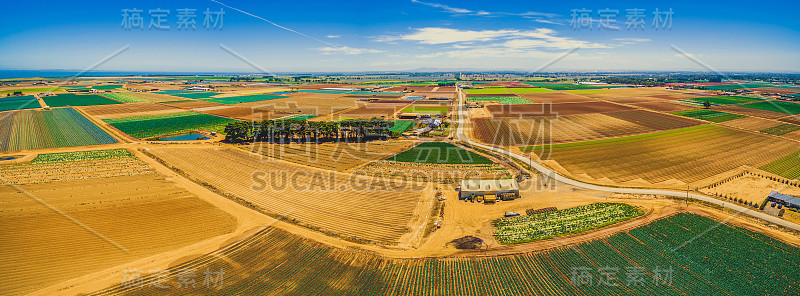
493,203,644,244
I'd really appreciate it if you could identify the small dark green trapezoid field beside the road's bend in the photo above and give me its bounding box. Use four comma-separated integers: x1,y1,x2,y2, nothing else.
387,142,492,164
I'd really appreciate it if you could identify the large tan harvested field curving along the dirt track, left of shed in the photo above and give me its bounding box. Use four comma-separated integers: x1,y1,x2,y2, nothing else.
151,148,426,243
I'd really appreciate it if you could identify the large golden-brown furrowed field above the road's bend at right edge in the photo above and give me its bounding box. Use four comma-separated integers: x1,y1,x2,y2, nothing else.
526,125,796,183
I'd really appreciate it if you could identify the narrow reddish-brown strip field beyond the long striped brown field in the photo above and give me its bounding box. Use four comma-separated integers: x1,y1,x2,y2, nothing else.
486,102,633,117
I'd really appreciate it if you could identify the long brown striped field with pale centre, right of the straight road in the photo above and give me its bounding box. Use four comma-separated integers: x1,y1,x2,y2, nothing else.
473,110,700,146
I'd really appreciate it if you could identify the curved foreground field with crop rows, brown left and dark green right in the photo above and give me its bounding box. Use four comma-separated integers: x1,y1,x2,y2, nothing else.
92,214,800,296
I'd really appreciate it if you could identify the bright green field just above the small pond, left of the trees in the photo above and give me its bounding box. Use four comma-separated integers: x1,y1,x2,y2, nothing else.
103,112,236,139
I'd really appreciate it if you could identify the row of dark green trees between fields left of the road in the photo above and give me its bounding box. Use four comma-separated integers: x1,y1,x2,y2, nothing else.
225,119,397,143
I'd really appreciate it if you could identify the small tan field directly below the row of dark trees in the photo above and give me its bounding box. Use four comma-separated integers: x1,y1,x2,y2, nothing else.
246,141,413,172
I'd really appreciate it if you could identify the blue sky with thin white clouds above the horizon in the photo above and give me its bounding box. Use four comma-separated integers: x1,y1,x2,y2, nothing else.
0,0,800,72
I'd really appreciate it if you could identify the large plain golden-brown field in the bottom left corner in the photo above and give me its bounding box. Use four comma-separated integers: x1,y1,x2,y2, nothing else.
0,174,236,295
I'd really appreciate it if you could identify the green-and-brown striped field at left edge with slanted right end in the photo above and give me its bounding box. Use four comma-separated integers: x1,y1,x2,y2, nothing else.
0,108,117,151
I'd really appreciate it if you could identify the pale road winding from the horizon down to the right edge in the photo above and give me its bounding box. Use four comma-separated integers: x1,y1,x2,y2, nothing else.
456,90,800,231
